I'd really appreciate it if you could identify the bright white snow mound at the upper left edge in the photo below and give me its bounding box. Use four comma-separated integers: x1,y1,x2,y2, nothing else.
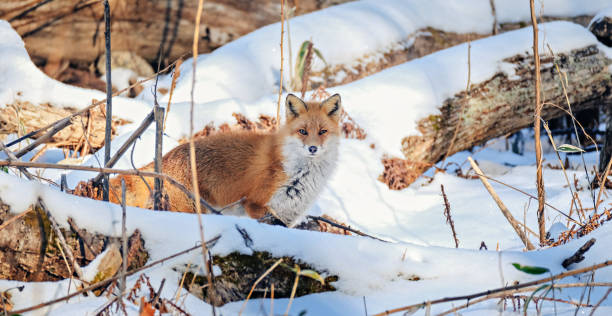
0,20,150,118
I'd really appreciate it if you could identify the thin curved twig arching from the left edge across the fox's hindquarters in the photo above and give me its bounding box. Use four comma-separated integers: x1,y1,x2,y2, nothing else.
0,160,220,214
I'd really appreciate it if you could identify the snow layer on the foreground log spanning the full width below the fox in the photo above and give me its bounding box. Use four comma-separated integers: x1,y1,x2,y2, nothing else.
0,175,612,315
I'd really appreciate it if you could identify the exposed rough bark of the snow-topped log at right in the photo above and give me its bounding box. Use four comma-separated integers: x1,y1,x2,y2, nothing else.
381,45,612,189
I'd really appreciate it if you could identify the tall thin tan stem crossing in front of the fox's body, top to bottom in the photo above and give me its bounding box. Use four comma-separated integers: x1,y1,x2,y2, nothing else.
189,0,216,308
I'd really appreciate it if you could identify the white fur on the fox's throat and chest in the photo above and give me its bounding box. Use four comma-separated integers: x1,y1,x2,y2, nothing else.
268,139,338,227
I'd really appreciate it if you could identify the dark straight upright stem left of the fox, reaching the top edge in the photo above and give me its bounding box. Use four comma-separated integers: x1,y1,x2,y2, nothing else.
102,0,113,201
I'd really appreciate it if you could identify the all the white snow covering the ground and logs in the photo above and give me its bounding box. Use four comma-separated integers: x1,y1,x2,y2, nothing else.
0,0,612,315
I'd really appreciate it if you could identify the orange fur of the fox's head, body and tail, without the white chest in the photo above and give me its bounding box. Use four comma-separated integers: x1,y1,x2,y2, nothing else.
110,95,341,218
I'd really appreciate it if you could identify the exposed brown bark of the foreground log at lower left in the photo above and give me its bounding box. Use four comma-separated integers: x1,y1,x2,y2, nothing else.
0,201,148,282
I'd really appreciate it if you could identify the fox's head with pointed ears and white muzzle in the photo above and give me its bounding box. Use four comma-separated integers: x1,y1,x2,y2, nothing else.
285,94,342,158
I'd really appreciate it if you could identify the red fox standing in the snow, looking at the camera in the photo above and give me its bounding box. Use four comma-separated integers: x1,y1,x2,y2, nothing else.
111,94,342,227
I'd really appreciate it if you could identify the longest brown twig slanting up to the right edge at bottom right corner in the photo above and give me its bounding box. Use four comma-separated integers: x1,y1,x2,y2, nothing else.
374,260,612,316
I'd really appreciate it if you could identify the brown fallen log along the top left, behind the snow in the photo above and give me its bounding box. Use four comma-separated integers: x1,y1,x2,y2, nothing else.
0,0,352,63
